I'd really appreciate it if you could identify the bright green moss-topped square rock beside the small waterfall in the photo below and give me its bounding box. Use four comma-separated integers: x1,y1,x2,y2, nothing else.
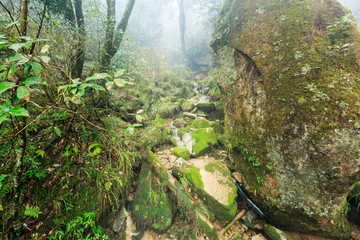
191,128,218,157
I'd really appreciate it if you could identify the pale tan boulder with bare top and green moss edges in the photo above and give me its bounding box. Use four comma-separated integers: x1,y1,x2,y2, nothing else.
180,158,237,221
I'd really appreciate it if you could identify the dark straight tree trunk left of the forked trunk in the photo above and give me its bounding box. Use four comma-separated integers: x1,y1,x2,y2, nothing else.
71,0,86,78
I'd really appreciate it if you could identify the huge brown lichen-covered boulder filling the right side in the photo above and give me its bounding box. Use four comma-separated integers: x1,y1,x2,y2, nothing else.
212,0,360,238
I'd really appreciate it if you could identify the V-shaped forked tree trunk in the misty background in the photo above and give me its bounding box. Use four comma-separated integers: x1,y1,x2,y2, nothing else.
101,0,136,70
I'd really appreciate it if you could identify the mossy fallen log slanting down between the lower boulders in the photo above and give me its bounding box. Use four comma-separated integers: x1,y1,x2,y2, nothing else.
146,149,223,240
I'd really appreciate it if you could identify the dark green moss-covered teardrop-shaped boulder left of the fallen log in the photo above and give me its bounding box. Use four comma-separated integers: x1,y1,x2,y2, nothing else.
132,164,175,234
